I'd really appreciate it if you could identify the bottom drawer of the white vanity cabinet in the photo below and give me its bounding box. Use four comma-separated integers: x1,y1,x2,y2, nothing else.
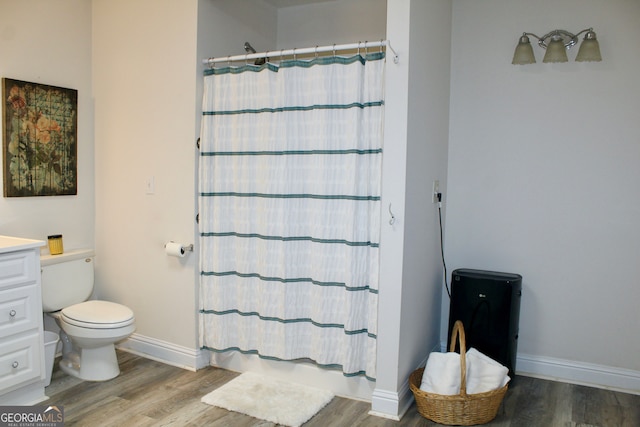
0,332,42,390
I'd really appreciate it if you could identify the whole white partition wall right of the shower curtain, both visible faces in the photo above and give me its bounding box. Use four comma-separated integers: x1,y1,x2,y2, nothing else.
372,0,451,416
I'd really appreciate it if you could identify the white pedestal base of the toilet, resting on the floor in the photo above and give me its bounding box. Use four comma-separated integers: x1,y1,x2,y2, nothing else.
59,344,120,381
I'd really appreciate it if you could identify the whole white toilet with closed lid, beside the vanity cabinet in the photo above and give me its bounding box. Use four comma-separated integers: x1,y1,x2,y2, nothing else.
40,249,135,381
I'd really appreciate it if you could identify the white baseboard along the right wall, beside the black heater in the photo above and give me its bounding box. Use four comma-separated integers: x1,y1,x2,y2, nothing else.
516,354,640,395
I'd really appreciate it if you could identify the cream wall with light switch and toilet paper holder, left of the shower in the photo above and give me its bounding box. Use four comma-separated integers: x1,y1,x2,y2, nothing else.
93,0,198,349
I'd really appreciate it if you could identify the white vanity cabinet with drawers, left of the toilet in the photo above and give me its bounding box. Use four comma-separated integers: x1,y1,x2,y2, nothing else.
0,236,46,405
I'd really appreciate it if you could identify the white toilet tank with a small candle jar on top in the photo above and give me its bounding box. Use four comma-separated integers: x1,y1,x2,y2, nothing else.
40,249,95,313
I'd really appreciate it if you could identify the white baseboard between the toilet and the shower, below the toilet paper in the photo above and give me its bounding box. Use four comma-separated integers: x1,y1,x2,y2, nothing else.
116,333,209,371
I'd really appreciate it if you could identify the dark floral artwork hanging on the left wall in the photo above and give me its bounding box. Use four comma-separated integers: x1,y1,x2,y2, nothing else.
2,78,78,197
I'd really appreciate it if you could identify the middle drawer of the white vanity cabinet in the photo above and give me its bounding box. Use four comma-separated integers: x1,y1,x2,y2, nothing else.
0,285,42,337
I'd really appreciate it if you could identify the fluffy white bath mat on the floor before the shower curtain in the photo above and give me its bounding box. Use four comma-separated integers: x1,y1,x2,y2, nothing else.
201,372,333,427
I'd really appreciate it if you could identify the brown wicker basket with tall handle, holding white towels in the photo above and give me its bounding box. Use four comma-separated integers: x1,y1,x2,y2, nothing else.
409,320,508,426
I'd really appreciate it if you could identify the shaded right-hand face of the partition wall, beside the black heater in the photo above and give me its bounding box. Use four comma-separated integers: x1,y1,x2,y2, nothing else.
400,0,451,392
